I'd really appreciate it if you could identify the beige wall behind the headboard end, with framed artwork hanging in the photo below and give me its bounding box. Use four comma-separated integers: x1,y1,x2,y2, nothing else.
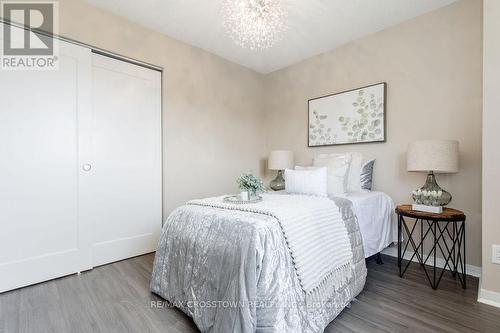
265,0,482,266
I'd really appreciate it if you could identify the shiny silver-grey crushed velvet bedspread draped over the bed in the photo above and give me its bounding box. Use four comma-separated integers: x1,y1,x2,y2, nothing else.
151,195,367,333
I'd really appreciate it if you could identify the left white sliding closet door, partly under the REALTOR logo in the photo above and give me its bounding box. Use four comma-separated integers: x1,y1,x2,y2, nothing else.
0,29,92,292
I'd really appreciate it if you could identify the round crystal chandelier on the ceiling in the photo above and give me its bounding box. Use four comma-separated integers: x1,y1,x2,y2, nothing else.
221,0,287,50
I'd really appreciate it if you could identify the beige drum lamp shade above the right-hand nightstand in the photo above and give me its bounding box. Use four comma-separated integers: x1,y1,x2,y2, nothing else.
407,140,458,173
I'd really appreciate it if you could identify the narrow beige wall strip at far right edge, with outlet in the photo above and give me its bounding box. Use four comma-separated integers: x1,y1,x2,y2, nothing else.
481,0,500,294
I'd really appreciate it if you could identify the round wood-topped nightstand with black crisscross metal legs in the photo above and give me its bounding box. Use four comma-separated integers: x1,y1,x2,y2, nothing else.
396,205,466,289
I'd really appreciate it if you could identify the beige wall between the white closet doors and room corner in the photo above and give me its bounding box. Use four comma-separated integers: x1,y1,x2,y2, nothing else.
50,0,265,214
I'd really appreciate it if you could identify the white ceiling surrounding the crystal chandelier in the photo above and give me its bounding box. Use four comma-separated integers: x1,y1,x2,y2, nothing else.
87,0,456,73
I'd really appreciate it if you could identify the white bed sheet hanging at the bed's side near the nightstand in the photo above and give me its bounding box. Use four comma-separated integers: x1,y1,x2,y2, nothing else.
340,191,398,258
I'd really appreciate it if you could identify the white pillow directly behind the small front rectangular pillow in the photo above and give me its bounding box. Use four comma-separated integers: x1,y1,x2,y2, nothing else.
313,154,350,195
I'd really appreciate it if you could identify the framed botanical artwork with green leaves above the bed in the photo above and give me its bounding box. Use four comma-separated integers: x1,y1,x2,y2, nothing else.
308,82,387,147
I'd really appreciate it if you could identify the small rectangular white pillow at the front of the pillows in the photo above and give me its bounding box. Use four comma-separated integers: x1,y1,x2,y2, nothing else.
285,168,328,197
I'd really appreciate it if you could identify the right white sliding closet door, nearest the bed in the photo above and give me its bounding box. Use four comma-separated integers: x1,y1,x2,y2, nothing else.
87,54,162,266
